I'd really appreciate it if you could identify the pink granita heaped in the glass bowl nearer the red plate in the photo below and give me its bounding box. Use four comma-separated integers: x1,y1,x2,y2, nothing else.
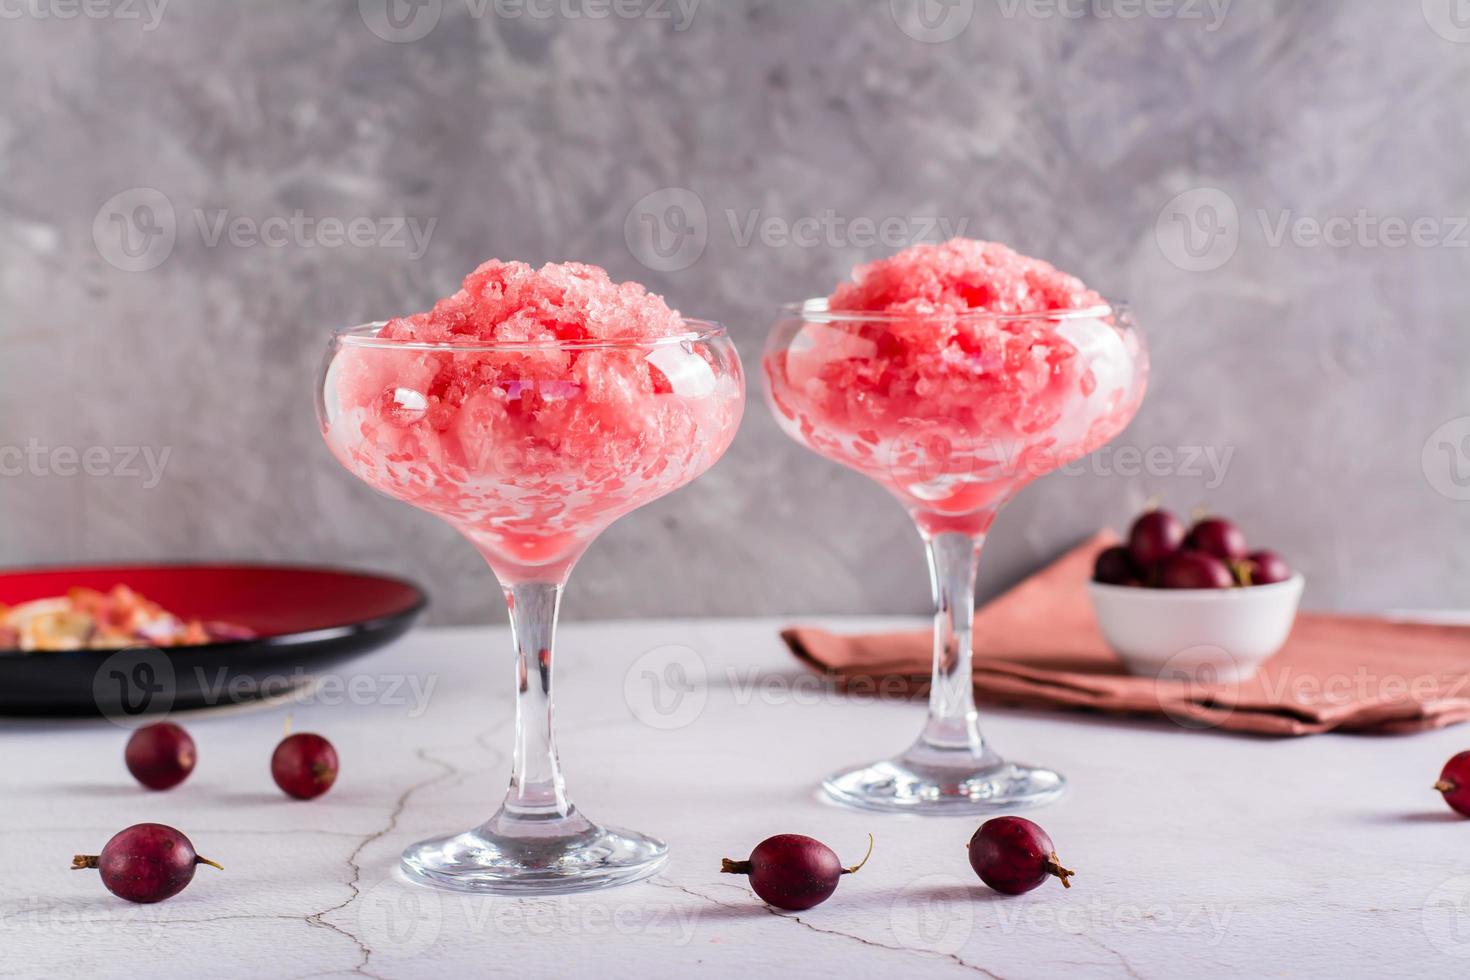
323,260,744,582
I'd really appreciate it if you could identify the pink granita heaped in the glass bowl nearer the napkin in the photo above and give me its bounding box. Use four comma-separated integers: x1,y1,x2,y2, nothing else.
764,238,1148,533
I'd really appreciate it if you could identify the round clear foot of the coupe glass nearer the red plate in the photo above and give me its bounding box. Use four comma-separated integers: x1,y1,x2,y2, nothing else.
400,824,669,896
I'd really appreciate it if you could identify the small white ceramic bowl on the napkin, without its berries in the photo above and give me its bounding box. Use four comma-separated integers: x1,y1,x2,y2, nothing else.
1088,574,1307,683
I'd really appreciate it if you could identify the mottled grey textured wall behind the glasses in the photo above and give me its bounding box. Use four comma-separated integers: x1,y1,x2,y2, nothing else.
0,0,1470,621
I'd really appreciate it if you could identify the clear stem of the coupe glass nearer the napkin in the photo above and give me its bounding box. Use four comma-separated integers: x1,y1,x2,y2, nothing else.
920,532,985,755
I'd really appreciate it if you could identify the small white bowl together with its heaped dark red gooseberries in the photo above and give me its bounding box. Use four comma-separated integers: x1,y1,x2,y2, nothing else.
1088,510,1305,683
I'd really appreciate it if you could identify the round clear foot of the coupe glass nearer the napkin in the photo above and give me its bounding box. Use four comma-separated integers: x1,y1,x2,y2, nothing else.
822,746,1067,817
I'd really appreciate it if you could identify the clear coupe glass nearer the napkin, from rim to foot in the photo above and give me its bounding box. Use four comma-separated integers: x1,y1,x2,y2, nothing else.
763,300,1148,814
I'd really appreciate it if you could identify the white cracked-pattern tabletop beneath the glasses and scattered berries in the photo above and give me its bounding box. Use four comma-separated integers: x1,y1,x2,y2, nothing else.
0,619,1470,980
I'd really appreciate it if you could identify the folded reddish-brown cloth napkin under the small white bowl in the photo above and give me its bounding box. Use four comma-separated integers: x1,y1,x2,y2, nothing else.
782,533,1470,735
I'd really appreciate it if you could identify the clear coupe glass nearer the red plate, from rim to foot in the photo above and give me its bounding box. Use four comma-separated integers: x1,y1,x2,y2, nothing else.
318,320,745,895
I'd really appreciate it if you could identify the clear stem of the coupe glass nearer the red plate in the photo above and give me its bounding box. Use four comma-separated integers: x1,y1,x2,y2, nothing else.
497,582,573,821
